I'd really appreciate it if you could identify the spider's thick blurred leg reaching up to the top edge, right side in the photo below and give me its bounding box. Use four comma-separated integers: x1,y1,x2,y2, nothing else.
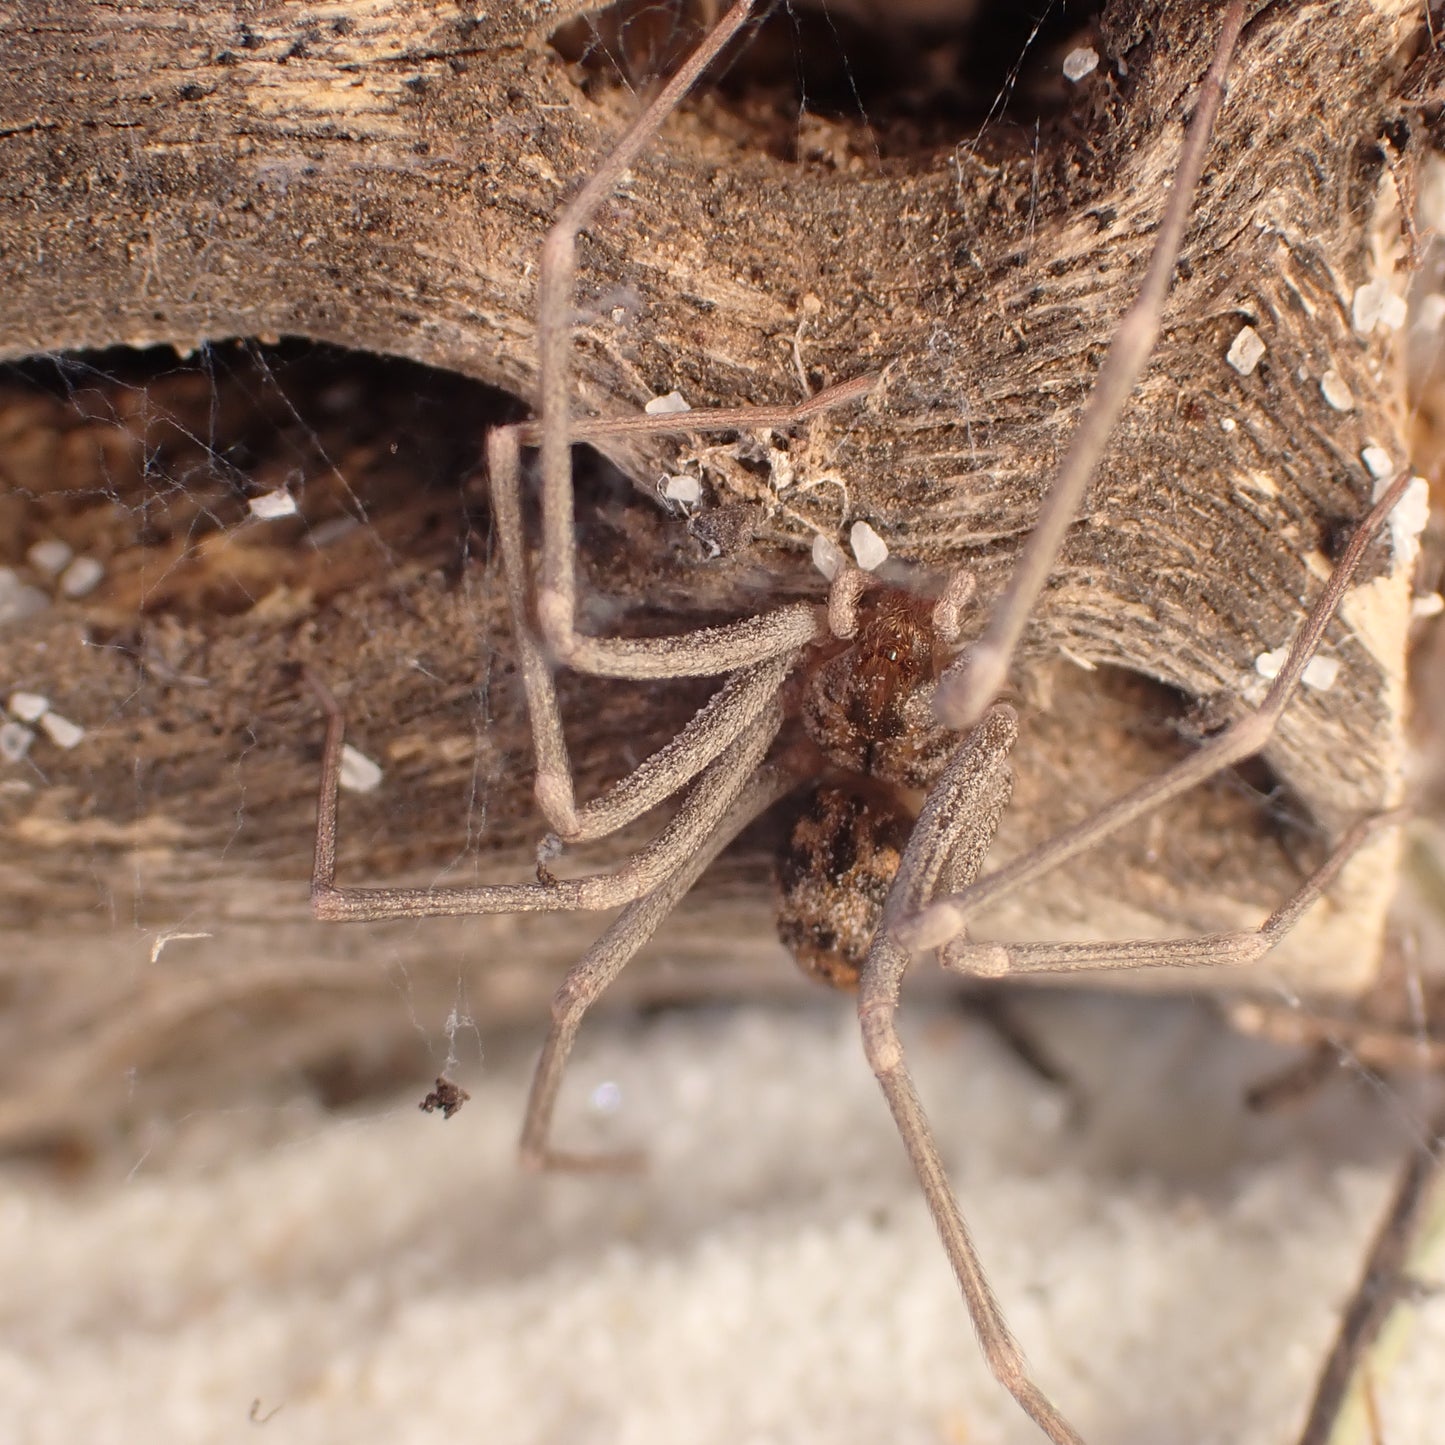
933,0,1244,728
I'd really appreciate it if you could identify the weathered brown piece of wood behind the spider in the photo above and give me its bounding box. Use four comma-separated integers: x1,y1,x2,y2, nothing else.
0,0,1438,1137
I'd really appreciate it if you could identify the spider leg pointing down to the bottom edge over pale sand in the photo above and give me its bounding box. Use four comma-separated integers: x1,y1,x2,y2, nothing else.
858,707,1082,1445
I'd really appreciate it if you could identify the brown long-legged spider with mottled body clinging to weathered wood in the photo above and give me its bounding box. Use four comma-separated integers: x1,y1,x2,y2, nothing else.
302,0,1409,1445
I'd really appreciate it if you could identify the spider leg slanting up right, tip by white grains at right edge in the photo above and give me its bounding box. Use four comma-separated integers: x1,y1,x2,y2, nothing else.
897,473,1410,951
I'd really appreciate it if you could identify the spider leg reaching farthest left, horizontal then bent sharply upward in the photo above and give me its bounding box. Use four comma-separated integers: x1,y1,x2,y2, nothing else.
305,670,782,922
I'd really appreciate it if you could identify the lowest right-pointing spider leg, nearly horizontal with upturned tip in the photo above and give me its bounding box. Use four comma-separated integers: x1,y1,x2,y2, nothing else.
939,812,1403,978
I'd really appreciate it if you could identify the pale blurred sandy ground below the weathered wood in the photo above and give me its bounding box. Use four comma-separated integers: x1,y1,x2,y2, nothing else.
0,996,1445,1445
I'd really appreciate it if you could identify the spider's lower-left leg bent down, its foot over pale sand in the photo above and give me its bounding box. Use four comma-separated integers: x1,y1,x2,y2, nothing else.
520,764,798,1169
